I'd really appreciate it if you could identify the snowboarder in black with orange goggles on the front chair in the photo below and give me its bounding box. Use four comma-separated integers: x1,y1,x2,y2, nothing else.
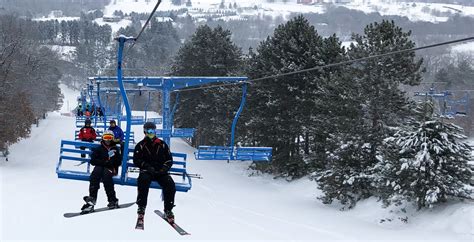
81,131,122,213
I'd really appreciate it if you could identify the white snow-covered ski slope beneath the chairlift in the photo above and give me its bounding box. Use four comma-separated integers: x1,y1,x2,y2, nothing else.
0,83,474,242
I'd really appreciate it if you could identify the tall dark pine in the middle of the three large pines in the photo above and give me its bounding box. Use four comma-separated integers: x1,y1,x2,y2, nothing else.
248,16,341,178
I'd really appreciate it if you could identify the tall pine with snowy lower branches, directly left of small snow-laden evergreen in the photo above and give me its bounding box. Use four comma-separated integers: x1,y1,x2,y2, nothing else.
313,21,422,208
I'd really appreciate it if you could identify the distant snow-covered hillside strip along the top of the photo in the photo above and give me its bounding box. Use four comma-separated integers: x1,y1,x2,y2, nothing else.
104,0,474,22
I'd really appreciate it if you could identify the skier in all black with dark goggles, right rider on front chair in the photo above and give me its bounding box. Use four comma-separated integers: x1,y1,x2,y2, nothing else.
133,122,176,223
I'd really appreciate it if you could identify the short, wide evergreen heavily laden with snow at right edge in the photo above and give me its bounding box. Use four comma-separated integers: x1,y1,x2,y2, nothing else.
375,101,472,209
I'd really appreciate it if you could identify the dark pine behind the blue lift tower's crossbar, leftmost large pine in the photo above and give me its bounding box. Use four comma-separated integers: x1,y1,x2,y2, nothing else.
171,25,242,145
